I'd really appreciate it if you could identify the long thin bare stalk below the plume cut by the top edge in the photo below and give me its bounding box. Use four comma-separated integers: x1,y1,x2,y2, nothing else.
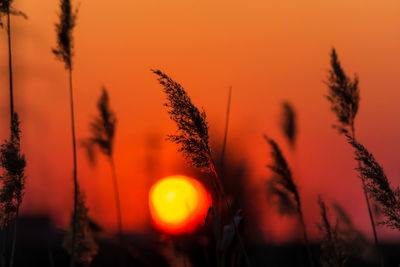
68,67,79,267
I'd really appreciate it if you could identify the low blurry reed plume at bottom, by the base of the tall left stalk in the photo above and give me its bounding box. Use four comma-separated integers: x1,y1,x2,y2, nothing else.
63,189,98,266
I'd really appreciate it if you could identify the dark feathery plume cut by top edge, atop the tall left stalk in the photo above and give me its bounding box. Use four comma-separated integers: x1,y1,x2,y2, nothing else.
52,0,78,69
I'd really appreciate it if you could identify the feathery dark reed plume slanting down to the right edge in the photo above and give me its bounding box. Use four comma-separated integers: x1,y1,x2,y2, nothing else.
347,136,400,230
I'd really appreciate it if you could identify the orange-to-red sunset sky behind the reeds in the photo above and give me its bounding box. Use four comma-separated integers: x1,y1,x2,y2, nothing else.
0,0,400,241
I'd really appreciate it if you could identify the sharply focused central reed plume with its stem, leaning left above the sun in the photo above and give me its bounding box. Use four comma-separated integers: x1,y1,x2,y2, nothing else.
151,70,250,266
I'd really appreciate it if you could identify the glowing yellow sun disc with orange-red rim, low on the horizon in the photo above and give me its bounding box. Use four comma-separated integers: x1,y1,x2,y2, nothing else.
149,175,211,234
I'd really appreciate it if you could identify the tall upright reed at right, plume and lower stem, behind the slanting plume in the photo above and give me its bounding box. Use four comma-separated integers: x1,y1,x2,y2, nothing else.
325,48,384,266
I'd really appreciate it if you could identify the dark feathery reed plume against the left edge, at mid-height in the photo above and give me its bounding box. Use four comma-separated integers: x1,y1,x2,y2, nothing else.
0,113,26,228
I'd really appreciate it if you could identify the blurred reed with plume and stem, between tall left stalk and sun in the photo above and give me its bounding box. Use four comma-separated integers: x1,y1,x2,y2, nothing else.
83,88,122,247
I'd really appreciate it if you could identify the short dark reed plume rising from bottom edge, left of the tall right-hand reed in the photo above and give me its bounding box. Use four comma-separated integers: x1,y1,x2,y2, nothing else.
318,197,348,267
